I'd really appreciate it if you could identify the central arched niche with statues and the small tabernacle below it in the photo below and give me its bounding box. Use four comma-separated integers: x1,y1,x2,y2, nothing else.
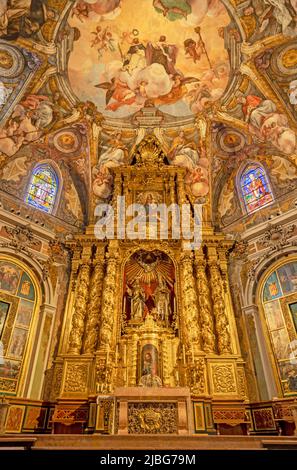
120,250,179,387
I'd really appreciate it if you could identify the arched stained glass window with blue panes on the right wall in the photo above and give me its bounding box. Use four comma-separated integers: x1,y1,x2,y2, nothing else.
236,162,274,214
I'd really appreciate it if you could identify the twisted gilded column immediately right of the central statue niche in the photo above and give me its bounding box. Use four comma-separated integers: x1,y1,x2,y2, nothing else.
181,253,201,352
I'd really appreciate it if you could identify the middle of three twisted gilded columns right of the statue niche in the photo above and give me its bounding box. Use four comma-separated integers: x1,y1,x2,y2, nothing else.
195,251,216,353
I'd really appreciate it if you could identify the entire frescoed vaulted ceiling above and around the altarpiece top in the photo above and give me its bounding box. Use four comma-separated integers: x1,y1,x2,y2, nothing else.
0,0,297,230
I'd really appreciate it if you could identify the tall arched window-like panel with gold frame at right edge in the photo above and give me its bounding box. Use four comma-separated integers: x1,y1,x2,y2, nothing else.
262,261,297,395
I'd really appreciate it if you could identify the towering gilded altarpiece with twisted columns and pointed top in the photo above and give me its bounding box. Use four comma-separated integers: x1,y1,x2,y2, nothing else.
52,137,247,433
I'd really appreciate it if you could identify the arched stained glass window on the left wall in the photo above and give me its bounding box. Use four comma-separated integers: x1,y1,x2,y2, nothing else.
25,163,59,214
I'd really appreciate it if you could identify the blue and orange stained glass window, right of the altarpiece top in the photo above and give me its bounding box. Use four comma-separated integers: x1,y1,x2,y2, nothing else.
240,165,273,213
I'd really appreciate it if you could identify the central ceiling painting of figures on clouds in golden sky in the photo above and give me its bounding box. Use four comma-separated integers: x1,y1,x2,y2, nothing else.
68,0,230,117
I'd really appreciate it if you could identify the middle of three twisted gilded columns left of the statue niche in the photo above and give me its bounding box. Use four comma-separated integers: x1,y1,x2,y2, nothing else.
83,247,104,353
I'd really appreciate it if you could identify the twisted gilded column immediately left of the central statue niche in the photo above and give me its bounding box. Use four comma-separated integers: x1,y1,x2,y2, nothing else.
99,244,118,349
